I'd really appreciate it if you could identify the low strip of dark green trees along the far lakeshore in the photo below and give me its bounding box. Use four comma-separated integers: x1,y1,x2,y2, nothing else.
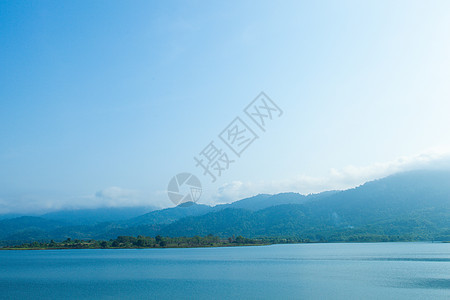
0,235,308,250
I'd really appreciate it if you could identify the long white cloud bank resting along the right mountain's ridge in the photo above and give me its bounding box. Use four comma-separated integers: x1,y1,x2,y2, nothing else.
211,149,450,204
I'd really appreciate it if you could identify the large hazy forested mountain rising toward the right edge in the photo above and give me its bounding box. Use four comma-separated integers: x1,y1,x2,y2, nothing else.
155,171,450,240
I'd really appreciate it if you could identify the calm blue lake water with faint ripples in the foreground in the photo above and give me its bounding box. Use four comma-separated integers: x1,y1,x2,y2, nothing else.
0,243,450,299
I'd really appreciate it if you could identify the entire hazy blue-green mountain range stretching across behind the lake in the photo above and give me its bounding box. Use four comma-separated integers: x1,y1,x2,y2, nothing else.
0,170,450,244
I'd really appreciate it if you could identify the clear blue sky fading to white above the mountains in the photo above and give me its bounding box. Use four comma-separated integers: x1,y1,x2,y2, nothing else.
0,1,450,214
